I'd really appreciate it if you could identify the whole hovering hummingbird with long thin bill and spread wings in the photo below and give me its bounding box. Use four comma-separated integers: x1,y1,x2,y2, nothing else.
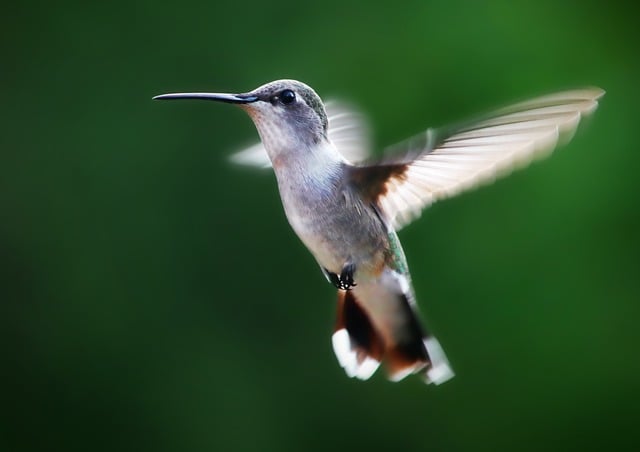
154,80,604,384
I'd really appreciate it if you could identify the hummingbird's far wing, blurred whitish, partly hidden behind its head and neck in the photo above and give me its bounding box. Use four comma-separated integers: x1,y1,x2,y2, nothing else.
229,101,371,168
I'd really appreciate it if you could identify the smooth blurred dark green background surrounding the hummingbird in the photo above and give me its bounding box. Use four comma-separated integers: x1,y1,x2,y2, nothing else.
0,0,640,451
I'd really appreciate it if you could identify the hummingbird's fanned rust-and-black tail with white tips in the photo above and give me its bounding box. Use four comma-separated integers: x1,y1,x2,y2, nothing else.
332,274,454,384
